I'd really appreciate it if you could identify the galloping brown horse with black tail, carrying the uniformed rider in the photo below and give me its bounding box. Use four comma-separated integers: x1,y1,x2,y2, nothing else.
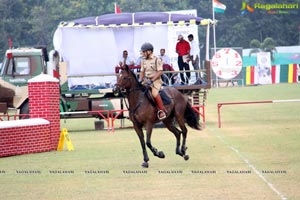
114,66,201,168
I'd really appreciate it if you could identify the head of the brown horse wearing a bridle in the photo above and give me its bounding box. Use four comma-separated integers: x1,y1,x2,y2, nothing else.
114,65,139,92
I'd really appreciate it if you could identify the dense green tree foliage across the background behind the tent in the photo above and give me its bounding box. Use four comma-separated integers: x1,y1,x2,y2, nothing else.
0,0,300,58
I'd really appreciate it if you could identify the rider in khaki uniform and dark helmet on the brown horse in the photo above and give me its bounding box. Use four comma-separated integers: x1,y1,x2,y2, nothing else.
140,43,166,120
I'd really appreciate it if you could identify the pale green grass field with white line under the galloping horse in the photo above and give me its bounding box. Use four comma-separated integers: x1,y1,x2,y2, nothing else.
0,84,300,200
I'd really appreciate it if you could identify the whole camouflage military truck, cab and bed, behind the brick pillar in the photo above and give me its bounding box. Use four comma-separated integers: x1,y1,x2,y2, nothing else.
0,47,121,118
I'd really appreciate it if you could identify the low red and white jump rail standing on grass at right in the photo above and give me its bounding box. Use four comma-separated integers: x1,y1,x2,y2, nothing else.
217,99,300,128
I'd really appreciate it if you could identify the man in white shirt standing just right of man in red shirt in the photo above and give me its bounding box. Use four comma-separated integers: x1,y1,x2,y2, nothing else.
188,34,201,84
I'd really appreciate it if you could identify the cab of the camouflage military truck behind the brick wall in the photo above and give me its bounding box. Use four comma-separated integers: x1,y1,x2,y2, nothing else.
0,47,47,114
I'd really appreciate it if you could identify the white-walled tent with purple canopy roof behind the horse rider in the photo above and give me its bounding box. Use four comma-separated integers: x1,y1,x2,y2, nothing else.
53,10,211,87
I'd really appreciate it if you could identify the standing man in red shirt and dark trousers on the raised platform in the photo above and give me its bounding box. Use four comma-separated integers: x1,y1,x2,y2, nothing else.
176,35,191,84
